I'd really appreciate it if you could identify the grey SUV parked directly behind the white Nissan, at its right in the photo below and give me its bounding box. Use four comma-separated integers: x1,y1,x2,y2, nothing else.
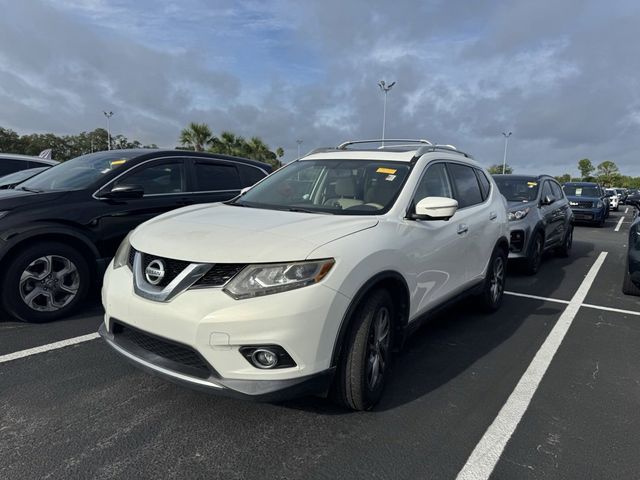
493,175,573,274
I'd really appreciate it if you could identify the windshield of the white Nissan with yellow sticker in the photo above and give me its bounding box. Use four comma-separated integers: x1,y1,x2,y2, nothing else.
231,160,411,215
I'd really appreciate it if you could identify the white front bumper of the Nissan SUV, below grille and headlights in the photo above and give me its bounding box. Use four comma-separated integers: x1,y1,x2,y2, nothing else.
101,267,349,400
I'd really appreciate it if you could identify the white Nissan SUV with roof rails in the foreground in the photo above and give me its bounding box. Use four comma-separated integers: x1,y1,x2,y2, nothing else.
100,140,509,410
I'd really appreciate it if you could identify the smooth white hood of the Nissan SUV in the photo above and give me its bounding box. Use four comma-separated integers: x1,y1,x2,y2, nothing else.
131,204,378,263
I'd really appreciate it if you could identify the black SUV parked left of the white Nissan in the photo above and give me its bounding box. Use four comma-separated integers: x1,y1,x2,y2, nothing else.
0,149,270,322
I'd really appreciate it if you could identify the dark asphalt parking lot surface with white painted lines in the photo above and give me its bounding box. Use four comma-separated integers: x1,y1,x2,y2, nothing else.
0,207,640,479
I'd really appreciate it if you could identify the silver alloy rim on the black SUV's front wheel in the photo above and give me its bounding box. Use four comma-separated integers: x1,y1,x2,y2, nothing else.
19,255,80,312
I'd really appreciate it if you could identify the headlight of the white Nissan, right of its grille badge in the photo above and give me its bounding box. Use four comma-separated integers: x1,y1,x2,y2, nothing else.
224,258,335,300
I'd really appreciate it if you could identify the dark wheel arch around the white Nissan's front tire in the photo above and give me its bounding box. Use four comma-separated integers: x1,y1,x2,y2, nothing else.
331,270,410,367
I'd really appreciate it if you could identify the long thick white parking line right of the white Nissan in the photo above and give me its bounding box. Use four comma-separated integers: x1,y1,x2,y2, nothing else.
456,252,607,480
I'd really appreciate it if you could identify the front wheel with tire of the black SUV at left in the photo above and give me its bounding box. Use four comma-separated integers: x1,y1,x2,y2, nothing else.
0,241,90,323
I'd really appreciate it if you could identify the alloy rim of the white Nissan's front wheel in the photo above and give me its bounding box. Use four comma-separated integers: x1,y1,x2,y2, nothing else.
366,307,391,390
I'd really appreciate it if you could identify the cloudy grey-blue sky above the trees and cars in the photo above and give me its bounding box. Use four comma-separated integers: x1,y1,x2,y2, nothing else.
0,0,640,175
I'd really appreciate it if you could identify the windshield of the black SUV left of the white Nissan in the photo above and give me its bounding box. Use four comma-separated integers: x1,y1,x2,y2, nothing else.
17,150,138,191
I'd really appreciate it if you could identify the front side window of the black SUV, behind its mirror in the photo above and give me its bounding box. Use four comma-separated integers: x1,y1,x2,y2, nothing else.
114,161,185,195
